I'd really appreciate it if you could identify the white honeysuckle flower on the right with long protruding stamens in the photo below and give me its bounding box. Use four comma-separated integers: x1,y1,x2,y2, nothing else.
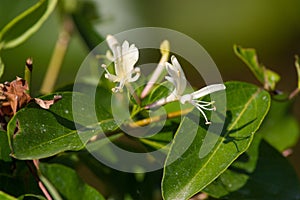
146,56,226,124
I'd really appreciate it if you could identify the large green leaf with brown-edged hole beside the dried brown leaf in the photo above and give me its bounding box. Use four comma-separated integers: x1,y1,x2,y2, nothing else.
8,92,117,160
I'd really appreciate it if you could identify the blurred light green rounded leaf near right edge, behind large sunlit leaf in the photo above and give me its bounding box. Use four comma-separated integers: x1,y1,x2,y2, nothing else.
259,101,300,152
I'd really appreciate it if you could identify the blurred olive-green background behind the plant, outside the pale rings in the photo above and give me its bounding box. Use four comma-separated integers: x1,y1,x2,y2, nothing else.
0,0,300,174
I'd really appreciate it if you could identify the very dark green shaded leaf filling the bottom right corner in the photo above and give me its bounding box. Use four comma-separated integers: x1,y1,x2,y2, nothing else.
227,141,300,200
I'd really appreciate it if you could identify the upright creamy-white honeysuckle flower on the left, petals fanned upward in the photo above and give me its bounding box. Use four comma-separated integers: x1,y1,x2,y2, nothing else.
102,35,141,92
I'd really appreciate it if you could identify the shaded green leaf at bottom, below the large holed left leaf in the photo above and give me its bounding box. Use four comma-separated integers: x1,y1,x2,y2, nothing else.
40,163,104,200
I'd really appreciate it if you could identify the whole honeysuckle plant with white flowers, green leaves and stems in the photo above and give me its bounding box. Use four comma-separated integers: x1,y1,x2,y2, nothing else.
0,0,300,200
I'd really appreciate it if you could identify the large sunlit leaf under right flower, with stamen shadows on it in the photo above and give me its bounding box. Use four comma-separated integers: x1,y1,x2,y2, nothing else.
162,82,270,199
